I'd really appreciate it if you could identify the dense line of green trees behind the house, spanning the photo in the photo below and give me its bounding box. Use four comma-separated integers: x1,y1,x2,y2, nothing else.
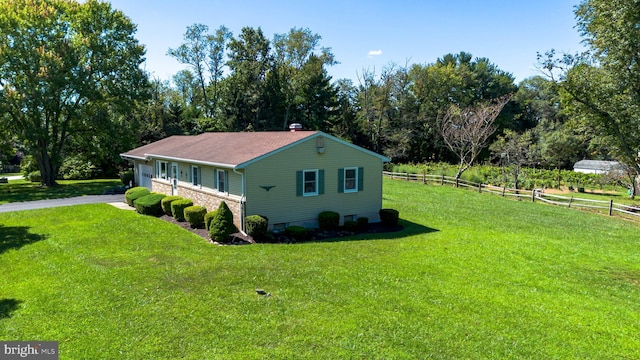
0,0,640,185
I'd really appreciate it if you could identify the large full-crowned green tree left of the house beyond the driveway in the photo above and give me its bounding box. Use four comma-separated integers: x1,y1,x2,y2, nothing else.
0,0,147,186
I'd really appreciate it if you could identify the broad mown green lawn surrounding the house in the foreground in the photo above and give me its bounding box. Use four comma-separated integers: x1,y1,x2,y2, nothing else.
0,180,640,359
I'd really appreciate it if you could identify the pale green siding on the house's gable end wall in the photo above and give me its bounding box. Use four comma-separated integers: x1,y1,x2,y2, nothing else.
242,134,382,224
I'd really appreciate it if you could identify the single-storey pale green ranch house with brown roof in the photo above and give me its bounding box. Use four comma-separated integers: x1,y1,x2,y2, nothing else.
121,127,389,231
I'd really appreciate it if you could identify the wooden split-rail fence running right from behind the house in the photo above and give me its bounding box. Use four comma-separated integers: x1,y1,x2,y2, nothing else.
382,171,640,219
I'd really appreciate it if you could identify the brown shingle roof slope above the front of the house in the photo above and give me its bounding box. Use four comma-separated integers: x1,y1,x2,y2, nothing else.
122,131,318,166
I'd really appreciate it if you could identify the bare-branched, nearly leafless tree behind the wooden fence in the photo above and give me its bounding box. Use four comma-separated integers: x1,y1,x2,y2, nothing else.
440,96,510,179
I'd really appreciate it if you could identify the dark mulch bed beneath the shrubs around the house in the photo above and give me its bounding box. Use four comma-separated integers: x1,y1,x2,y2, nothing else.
159,215,402,245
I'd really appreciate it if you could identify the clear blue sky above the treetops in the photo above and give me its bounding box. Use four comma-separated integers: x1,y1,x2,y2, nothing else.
110,0,583,84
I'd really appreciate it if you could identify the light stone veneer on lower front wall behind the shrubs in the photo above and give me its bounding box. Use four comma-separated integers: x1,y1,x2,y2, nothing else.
152,180,241,229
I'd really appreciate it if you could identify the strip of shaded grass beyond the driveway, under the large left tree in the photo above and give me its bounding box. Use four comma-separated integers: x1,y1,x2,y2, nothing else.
0,179,122,205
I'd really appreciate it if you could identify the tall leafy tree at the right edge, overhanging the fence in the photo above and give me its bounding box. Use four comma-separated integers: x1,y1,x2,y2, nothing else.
543,0,640,191
